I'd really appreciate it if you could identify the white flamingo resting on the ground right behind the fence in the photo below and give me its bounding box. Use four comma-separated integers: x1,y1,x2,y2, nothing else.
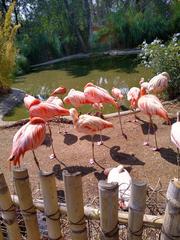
104,165,132,210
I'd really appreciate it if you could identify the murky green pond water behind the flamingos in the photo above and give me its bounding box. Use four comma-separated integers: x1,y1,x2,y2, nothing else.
4,55,153,121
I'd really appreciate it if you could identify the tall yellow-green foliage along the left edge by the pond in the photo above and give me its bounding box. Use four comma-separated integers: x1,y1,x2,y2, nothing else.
0,2,20,92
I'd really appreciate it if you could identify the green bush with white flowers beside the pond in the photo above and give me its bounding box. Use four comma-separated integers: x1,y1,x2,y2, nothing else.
139,33,180,99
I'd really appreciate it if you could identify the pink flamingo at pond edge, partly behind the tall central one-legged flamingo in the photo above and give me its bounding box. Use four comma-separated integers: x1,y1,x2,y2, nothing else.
63,88,93,108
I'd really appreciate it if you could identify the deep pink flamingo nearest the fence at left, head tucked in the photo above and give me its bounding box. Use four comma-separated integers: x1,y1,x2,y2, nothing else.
8,117,46,170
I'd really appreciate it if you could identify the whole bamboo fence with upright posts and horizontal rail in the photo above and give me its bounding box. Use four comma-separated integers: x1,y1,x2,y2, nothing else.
0,168,180,240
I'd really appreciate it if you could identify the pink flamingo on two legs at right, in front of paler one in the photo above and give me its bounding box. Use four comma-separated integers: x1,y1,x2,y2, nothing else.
138,88,170,151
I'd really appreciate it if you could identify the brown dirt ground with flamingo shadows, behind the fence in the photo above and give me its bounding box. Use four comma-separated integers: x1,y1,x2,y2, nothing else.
0,103,180,206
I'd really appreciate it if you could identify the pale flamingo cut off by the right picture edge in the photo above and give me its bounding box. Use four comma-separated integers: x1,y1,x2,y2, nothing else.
171,112,180,180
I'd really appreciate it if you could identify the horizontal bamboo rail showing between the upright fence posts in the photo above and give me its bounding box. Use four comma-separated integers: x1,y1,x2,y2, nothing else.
12,195,163,229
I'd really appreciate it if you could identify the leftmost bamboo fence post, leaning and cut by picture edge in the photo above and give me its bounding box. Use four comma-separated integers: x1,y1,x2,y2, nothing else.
0,173,21,240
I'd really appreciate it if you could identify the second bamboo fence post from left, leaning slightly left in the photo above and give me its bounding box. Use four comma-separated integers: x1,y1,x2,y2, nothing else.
13,168,40,240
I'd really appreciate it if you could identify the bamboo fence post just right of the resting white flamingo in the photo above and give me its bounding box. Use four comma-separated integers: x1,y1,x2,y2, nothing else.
128,181,146,240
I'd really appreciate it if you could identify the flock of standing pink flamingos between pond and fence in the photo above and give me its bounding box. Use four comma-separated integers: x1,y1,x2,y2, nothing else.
8,72,180,182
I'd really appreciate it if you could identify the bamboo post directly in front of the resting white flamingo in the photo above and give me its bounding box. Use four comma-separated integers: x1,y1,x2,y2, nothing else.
98,181,119,240
